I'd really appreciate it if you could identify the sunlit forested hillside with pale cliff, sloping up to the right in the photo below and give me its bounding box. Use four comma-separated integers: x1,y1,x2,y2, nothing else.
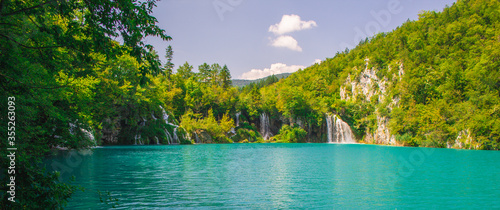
252,0,500,149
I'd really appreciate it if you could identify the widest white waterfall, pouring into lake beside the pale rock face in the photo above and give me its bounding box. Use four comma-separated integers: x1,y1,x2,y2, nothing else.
326,115,356,144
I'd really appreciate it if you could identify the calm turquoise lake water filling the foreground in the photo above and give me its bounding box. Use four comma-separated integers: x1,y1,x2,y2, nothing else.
48,144,500,209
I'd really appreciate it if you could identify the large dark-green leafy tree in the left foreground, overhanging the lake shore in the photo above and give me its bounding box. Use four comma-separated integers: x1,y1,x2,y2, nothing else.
0,0,171,209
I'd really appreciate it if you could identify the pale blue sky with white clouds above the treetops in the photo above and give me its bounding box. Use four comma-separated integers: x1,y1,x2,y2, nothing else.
147,0,455,79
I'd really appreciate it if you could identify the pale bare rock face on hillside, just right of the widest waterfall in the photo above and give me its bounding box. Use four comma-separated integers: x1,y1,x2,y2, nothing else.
340,58,404,145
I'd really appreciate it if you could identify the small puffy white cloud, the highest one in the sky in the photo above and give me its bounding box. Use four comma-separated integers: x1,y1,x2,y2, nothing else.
269,15,318,35
